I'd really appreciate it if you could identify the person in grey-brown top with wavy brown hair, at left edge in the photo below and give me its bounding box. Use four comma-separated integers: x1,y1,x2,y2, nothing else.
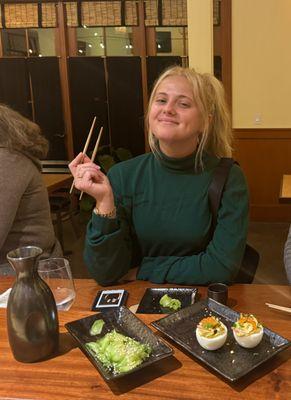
0,104,62,264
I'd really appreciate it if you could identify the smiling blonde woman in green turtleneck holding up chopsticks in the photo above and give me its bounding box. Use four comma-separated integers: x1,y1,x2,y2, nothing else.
70,67,248,285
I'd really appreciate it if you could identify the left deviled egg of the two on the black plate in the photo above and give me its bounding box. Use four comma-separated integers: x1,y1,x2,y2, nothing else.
196,316,227,350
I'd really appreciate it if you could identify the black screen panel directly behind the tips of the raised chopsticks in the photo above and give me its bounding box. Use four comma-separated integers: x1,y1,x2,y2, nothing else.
68,57,109,155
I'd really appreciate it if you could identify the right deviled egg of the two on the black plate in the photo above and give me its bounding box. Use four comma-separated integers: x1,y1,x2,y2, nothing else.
232,314,264,349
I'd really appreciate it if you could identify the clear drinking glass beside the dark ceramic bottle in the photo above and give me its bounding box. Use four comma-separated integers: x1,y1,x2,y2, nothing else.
38,258,76,311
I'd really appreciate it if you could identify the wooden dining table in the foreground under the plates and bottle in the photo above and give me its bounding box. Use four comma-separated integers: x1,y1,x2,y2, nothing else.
0,277,291,400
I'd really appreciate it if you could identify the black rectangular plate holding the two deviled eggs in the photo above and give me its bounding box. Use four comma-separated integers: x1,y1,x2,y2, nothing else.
152,299,291,382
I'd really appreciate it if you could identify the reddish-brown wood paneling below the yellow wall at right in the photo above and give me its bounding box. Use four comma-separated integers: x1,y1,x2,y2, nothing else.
234,129,291,222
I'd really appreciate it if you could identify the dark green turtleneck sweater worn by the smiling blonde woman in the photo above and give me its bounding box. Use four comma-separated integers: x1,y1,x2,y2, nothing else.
84,153,248,285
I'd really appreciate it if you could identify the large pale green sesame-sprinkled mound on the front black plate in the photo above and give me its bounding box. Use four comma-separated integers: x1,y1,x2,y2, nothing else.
86,330,152,374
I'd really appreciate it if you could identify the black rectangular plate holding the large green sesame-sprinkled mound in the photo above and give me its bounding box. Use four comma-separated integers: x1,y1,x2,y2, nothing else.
65,306,173,381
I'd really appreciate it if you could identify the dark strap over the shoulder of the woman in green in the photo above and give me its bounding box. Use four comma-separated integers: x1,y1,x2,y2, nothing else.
208,157,237,232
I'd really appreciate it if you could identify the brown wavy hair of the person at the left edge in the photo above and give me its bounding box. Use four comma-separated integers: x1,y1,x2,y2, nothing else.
0,104,48,160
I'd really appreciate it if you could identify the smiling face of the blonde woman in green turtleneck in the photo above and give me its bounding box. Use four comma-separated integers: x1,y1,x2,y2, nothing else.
149,76,202,157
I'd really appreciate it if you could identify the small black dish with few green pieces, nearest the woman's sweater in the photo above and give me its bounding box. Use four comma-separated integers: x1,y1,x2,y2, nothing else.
136,288,198,314
